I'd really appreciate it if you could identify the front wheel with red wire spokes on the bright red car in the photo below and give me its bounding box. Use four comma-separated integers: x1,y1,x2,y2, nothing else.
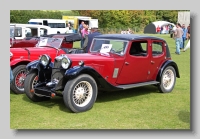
10,65,26,94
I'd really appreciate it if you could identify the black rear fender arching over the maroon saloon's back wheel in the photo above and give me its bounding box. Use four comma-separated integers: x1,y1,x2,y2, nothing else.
156,60,180,81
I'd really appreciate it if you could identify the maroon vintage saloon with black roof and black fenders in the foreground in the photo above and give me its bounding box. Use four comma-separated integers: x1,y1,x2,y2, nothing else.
24,34,180,113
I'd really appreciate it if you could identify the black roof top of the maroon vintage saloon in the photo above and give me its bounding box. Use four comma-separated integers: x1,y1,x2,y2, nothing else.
94,34,165,41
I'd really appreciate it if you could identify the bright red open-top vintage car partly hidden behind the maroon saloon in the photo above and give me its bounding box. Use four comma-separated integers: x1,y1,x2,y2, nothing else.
10,33,83,94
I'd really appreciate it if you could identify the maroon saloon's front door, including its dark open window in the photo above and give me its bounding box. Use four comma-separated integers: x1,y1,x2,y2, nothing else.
116,40,151,84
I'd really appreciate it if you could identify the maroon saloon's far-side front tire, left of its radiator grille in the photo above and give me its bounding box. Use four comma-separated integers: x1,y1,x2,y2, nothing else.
24,72,50,102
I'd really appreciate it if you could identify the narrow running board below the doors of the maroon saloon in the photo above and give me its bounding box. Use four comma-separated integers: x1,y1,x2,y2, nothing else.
116,81,160,89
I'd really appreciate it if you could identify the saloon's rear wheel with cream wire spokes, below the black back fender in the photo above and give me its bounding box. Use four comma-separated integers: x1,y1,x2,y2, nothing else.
158,66,176,93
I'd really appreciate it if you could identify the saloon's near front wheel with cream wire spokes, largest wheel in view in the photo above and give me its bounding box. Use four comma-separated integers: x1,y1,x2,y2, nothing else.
63,74,98,113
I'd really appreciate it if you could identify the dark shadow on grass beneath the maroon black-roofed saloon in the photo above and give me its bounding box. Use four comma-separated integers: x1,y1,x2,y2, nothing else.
20,86,158,113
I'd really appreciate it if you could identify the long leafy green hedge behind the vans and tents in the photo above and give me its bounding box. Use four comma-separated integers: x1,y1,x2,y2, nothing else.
10,10,189,29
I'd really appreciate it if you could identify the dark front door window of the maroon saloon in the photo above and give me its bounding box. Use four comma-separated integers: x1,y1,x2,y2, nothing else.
129,41,148,56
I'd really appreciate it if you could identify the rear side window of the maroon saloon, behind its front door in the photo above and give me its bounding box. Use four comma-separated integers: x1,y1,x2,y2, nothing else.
152,41,163,56
